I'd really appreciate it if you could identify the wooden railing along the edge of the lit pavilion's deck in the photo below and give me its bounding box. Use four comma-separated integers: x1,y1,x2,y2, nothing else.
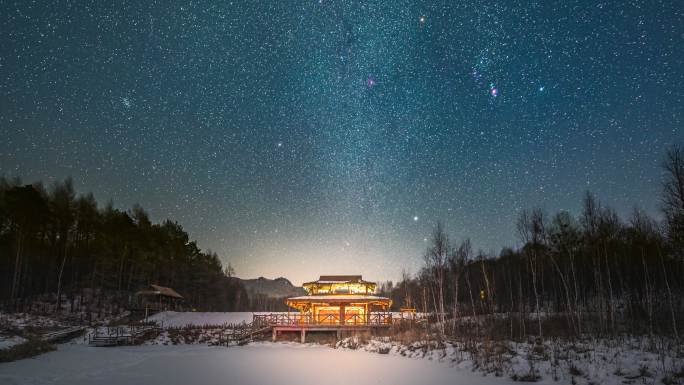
252,312,392,327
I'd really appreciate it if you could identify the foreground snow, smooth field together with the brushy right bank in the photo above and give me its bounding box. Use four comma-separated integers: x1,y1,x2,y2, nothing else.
0,339,682,385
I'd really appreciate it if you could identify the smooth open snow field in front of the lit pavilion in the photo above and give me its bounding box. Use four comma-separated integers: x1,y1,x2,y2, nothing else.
0,343,516,385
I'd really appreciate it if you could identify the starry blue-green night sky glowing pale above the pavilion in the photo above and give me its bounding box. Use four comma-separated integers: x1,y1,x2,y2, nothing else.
0,0,684,283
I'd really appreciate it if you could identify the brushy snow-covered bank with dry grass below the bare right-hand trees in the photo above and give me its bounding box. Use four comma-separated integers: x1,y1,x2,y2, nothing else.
336,337,684,385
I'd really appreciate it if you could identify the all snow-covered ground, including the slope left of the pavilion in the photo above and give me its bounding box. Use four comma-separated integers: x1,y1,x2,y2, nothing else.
0,312,684,385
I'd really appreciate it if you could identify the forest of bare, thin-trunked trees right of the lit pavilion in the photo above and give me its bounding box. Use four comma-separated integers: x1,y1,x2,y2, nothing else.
380,147,684,338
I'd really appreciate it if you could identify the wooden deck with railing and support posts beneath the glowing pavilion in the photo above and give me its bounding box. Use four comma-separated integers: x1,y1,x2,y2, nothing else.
252,312,392,343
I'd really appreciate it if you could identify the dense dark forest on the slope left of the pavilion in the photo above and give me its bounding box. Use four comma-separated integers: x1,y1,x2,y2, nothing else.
0,177,249,311
